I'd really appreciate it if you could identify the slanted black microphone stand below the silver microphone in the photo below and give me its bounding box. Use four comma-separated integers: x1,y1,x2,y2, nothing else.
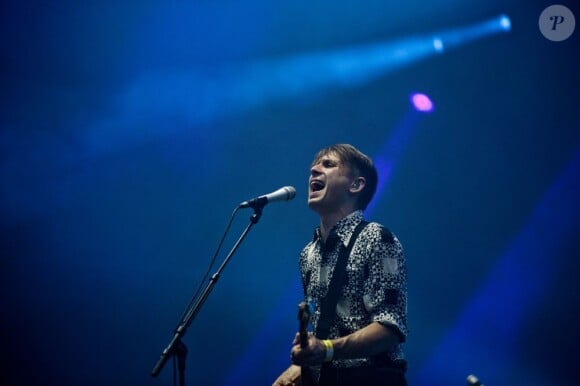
151,203,266,386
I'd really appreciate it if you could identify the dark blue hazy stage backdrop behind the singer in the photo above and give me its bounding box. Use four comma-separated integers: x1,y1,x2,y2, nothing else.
0,0,580,386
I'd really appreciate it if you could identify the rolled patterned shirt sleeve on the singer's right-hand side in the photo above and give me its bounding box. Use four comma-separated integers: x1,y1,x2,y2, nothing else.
363,224,407,341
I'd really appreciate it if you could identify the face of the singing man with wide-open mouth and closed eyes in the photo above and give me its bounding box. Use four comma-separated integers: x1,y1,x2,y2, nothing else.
308,153,353,214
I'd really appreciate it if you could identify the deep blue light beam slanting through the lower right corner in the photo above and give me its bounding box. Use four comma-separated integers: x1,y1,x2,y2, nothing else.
410,151,580,385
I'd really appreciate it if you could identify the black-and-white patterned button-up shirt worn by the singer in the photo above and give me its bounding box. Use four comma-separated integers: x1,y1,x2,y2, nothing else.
300,211,407,367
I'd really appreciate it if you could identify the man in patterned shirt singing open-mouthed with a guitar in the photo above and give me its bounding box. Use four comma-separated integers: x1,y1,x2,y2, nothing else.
274,144,407,386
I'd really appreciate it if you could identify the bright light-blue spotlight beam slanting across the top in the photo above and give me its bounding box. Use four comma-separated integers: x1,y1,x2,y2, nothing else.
83,15,510,153
